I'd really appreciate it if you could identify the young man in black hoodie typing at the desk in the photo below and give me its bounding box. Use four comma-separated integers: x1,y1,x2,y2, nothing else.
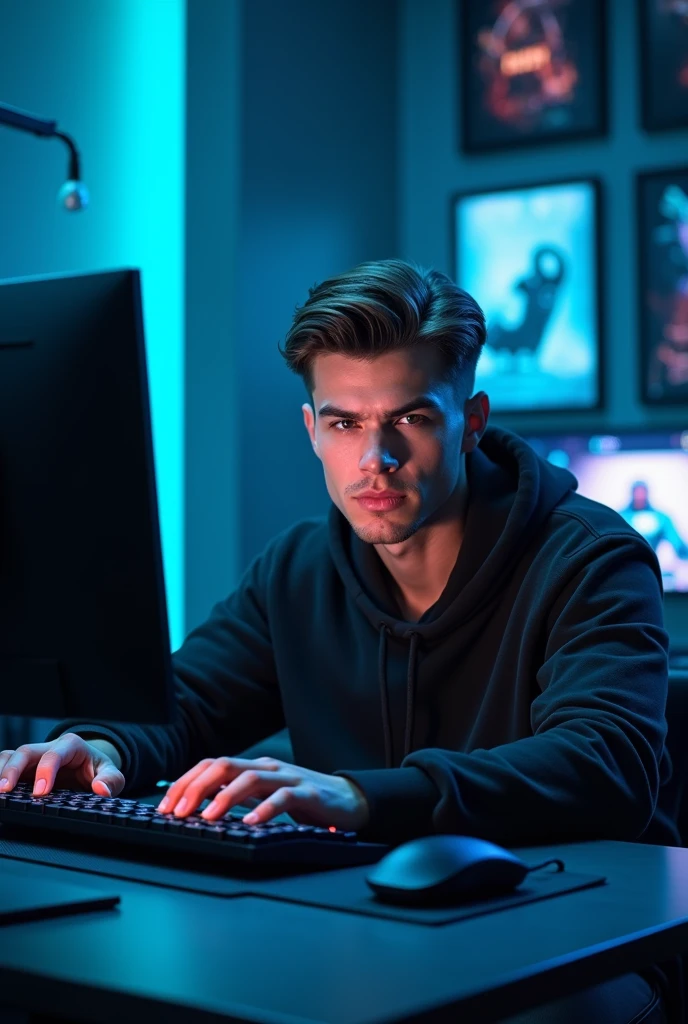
0,260,678,1024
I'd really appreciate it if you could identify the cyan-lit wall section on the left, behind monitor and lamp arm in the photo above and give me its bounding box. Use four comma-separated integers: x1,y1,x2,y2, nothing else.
0,0,186,647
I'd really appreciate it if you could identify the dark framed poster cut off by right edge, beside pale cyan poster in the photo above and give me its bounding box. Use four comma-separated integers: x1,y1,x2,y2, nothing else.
636,166,688,404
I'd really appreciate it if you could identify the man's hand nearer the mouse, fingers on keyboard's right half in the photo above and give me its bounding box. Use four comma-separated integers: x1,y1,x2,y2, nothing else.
158,758,369,831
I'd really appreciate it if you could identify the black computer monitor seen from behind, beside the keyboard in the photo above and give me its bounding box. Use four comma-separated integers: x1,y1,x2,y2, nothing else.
0,269,173,724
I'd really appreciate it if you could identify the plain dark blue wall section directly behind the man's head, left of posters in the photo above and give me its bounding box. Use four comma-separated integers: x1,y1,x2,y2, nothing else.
234,0,398,566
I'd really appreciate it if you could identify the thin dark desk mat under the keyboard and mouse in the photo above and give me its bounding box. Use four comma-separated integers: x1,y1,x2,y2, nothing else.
0,826,607,925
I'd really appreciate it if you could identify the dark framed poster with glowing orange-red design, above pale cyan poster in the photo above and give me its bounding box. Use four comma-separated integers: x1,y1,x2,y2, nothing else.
460,0,607,153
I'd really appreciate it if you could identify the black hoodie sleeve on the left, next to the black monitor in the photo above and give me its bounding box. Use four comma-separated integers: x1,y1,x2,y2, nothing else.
46,554,285,793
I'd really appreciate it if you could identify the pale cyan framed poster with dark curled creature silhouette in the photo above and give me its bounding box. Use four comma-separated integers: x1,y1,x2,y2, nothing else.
454,178,602,413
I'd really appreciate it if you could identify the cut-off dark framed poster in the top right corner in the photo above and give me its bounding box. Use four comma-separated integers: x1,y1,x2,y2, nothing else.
638,0,688,131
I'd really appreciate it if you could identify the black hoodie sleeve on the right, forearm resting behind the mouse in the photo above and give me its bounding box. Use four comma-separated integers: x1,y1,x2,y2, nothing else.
337,535,669,846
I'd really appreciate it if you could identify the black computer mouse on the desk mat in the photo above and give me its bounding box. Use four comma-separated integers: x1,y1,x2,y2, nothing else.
366,836,531,906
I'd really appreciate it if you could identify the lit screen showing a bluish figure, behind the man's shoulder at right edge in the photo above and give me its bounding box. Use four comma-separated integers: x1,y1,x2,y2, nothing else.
526,428,688,593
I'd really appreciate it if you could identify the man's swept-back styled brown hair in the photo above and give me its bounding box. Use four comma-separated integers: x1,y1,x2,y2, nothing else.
277,259,485,402
